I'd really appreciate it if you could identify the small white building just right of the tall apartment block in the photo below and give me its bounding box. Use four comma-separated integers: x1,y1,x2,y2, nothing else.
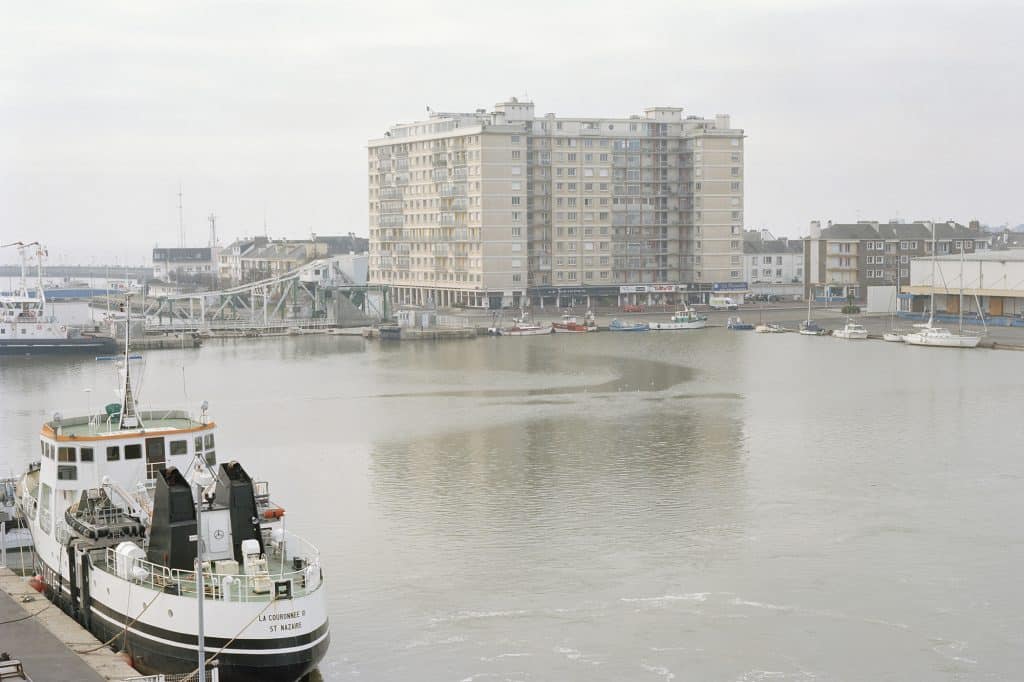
743,229,804,297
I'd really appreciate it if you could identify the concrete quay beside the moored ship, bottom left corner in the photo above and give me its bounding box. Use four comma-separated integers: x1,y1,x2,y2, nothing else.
0,566,139,682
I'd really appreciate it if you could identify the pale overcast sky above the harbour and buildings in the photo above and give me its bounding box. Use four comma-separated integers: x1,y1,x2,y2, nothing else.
0,0,1024,263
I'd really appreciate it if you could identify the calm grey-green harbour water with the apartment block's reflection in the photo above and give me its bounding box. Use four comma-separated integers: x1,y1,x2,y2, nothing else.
0,303,1024,681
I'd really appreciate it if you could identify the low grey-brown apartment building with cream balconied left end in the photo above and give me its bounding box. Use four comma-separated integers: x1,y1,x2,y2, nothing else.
804,220,986,302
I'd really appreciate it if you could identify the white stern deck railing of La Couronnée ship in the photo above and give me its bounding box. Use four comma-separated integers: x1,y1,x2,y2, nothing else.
96,532,323,603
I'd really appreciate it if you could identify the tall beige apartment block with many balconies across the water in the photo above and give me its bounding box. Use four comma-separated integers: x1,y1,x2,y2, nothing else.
368,98,746,308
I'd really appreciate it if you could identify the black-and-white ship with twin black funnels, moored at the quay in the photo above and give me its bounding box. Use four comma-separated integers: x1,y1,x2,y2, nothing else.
17,319,330,681
